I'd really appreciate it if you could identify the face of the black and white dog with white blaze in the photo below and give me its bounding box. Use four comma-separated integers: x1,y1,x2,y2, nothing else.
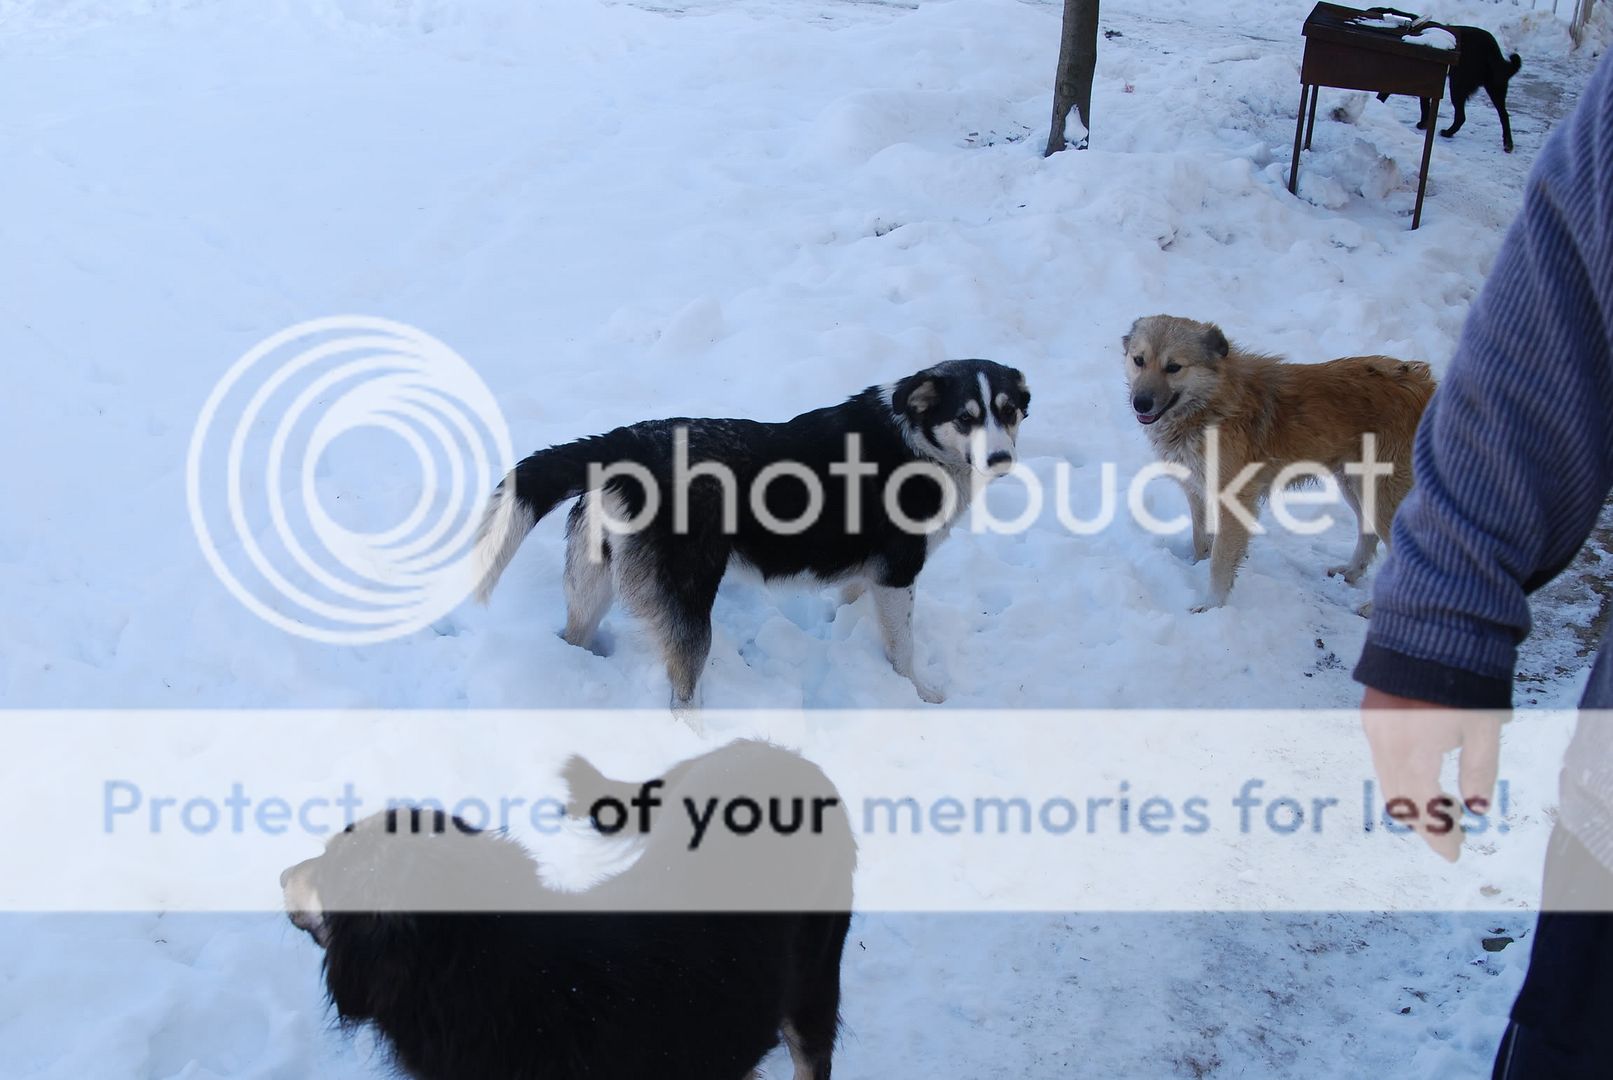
890,359,1031,477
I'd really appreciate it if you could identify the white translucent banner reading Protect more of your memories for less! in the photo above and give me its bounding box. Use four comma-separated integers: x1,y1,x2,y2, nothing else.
0,709,1587,911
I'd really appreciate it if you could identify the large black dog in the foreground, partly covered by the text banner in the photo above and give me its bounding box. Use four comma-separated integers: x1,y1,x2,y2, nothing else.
281,741,857,1080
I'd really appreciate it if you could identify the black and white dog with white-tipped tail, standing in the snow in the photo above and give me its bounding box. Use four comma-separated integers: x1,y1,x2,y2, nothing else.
476,359,1031,709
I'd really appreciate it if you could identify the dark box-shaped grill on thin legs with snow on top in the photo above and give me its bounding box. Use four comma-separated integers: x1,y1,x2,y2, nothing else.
1289,3,1457,229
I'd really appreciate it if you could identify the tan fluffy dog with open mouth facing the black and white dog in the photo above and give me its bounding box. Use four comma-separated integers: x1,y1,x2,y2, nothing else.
1121,314,1434,611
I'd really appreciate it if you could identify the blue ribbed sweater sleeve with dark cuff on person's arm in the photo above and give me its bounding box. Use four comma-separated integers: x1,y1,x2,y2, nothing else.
1355,52,1613,708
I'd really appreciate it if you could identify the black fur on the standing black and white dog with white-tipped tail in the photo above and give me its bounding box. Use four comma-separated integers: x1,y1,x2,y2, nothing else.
477,359,1031,703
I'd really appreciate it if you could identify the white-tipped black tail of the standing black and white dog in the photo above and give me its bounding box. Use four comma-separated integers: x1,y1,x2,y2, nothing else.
474,427,642,603
